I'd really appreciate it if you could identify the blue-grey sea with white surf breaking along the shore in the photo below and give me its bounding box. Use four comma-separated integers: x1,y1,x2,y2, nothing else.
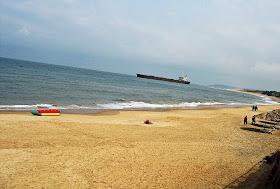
0,57,278,113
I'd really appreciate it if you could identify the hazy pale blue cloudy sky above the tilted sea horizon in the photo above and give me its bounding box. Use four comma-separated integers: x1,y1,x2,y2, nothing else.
0,0,280,91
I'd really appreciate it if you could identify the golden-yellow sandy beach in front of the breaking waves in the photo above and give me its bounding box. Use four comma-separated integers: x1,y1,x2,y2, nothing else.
0,106,280,188
